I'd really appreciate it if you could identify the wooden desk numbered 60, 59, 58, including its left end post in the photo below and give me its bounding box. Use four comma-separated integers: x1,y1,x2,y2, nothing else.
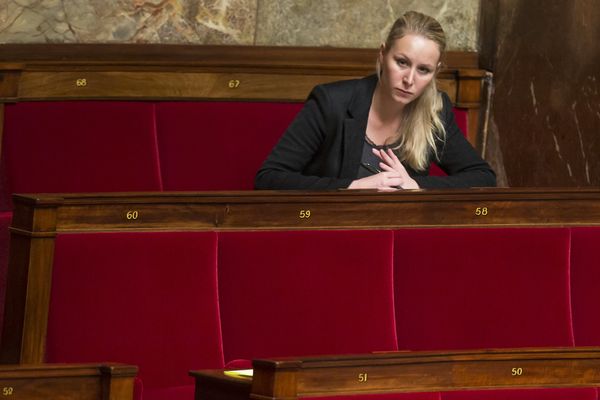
0,188,600,364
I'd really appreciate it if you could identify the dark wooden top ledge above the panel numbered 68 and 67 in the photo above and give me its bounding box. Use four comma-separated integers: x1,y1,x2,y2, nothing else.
0,43,478,74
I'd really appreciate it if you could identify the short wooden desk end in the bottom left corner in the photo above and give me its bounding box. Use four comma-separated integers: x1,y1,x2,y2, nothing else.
0,364,137,400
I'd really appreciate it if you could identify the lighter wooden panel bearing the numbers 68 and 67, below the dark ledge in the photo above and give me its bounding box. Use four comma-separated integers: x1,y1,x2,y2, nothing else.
18,71,462,107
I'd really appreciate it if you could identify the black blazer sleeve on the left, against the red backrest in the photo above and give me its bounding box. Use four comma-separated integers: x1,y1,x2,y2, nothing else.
254,85,352,189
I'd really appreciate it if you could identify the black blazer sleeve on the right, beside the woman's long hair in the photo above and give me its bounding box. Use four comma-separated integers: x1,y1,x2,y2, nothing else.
413,93,496,189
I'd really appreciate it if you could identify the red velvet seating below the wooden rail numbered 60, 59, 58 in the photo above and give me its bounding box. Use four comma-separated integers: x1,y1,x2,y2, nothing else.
47,228,600,400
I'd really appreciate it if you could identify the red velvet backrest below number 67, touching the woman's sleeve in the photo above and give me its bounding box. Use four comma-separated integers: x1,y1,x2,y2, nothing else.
156,101,302,190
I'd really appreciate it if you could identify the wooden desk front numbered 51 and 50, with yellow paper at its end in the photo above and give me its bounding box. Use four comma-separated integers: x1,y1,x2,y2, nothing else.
190,348,600,400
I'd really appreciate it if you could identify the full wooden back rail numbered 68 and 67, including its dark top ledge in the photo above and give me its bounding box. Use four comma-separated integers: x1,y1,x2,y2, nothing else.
0,44,482,103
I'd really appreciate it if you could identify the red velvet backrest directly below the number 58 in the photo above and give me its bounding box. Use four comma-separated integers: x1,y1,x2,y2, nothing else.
394,228,573,350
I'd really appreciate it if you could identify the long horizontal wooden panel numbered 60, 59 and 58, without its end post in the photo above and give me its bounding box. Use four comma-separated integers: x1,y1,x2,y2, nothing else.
13,188,600,234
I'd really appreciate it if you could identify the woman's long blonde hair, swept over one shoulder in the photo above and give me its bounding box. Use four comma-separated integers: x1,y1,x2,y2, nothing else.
377,11,446,171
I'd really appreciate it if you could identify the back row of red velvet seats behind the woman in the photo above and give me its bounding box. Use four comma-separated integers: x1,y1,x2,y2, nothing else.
0,101,467,334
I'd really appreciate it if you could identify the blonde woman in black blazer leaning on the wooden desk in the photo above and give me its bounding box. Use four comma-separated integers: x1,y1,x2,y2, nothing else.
255,11,496,191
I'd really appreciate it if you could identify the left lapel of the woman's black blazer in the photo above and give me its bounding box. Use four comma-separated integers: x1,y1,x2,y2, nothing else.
340,75,377,179
